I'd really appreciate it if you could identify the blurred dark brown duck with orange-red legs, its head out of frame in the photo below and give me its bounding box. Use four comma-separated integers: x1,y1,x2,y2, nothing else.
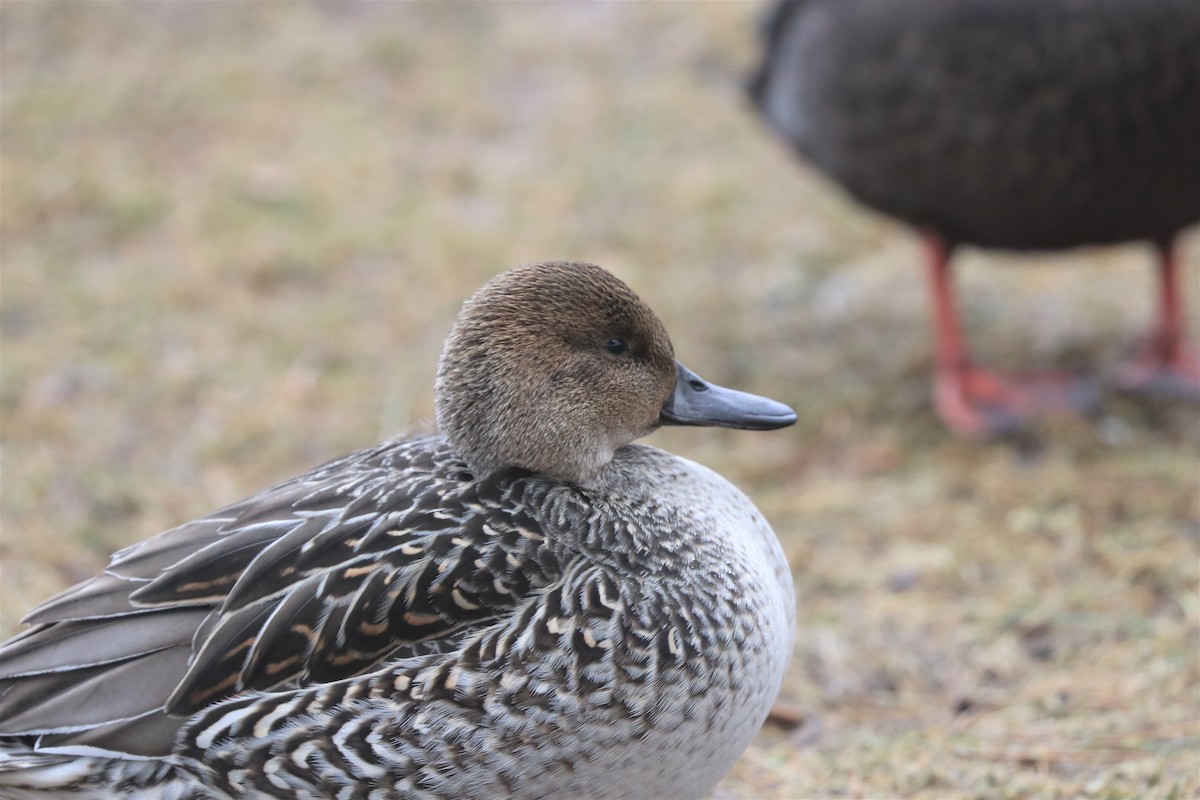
751,0,1200,434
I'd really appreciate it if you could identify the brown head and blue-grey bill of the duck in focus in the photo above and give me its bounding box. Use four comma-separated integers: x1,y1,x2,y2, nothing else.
434,263,796,485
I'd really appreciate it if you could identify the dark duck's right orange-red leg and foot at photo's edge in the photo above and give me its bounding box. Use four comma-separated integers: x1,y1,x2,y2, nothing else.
1117,239,1200,401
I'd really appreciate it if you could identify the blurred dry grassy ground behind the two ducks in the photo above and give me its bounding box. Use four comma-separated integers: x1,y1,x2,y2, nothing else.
0,2,1200,798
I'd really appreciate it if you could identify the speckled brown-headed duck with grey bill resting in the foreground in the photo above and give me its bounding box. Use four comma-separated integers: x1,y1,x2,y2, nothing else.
0,264,796,800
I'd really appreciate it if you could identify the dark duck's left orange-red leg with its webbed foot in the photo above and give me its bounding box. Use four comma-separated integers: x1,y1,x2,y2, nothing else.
924,234,1099,437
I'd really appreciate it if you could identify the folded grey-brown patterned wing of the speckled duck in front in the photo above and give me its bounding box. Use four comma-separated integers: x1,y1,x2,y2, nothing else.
0,439,571,754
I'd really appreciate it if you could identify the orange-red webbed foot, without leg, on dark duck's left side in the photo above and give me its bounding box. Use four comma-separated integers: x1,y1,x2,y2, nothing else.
934,366,1100,438
